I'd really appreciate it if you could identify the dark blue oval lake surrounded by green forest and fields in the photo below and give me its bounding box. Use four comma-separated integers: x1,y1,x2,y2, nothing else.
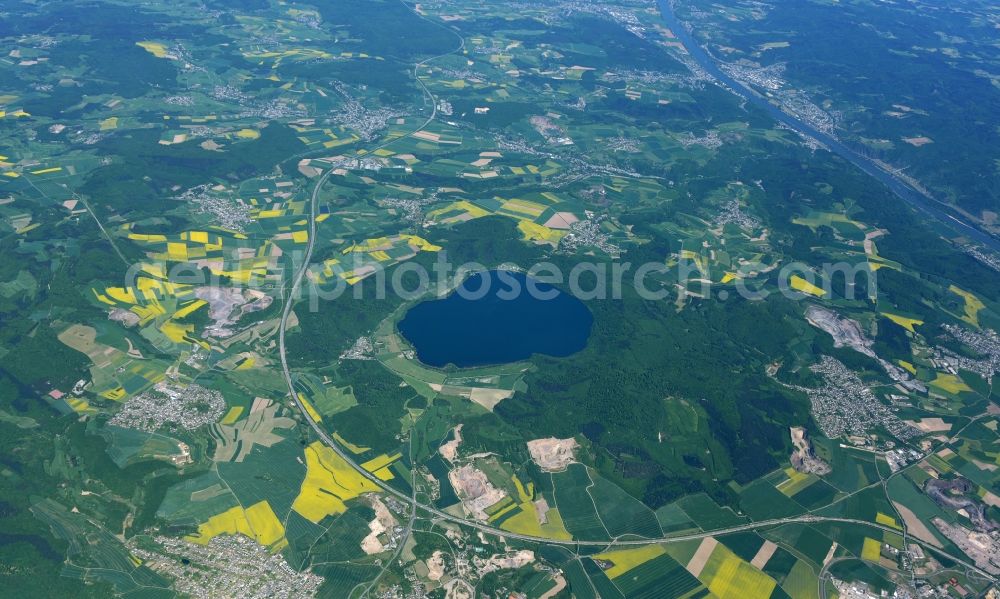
398,271,594,368
